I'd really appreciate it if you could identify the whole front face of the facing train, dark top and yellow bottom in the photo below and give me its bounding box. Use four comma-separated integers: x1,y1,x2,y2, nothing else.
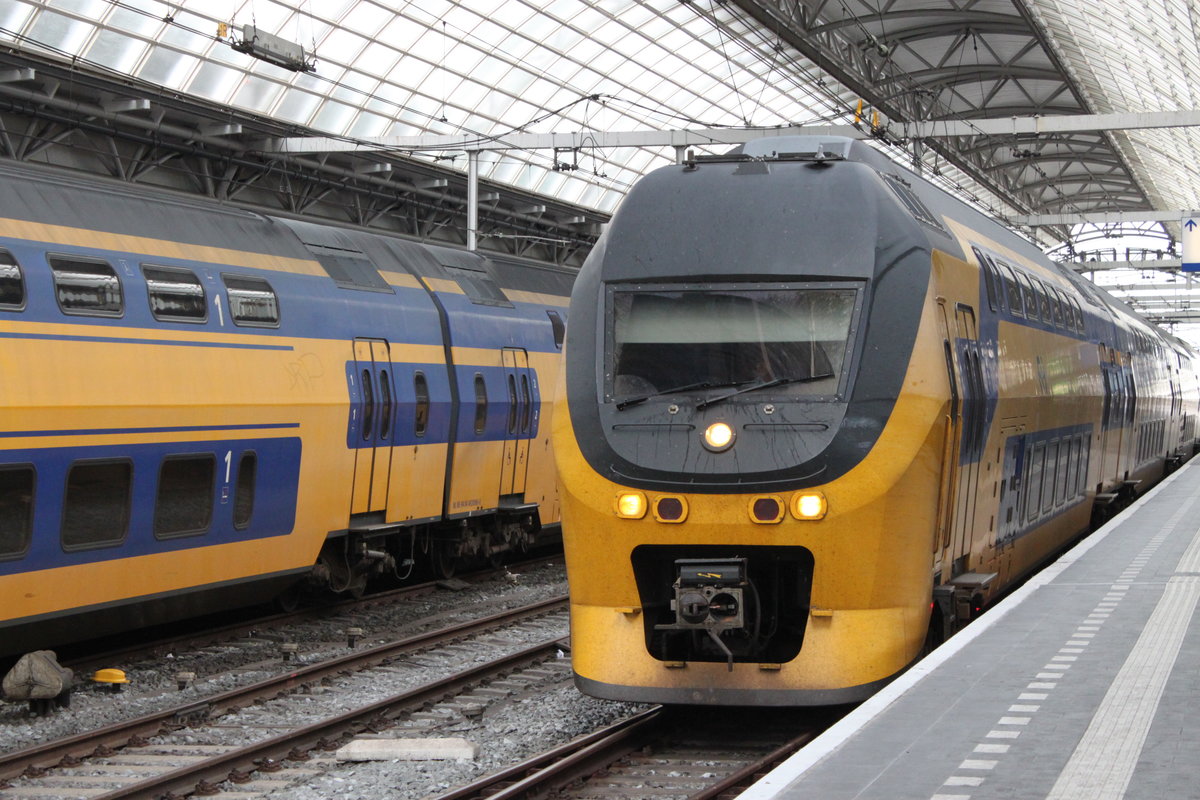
553,143,949,705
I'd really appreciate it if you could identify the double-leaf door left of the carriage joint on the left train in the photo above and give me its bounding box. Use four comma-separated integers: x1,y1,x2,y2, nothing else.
350,338,396,515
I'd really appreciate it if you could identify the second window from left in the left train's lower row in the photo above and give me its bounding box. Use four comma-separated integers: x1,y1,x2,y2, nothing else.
61,461,133,551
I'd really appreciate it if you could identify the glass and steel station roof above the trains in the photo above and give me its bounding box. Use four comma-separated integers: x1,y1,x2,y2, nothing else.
7,0,1200,335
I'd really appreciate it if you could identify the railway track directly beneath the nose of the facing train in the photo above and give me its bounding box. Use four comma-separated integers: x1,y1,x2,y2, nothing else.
437,706,838,800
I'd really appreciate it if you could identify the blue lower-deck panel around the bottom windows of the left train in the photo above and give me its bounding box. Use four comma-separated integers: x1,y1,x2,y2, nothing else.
0,437,302,575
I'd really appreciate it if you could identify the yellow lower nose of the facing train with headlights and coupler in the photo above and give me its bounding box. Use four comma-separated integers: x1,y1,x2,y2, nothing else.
554,277,947,705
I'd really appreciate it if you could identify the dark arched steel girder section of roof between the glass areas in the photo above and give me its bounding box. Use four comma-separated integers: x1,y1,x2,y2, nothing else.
731,0,1150,225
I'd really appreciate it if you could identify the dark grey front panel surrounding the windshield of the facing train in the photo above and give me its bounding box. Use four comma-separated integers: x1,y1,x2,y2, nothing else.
566,144,931,493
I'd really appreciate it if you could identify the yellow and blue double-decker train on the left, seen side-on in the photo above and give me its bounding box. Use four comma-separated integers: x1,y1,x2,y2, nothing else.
0,160,575,655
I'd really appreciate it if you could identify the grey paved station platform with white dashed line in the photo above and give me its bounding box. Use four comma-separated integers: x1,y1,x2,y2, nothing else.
739,458,1200,800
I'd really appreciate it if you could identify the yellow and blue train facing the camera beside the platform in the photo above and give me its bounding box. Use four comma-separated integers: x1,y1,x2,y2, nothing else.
553,137,1200,705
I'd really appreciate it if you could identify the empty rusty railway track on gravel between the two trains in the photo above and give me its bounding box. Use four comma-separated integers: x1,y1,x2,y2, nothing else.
0,596,570,800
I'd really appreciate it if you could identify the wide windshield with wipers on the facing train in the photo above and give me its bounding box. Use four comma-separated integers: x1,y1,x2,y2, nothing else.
608,284,858,403
